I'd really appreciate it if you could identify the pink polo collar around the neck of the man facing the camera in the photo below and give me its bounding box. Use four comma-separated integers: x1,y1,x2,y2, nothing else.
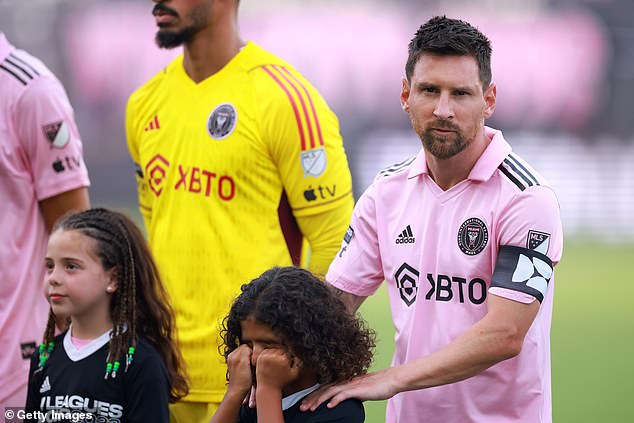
407,126,511,181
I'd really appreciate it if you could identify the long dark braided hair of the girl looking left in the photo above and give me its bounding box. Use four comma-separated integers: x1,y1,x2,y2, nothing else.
44,208,189,402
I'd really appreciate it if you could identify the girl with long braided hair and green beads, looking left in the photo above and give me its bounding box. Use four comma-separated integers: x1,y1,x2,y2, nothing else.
26,209,188,422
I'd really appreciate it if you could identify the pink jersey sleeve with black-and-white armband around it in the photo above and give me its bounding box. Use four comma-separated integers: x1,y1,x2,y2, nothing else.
489,186,563,303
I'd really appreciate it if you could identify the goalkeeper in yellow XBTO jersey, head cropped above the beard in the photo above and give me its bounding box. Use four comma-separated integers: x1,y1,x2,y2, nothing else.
126,0,353,423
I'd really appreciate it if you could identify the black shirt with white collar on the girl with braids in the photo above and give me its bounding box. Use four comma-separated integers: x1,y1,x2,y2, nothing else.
25,331,170,423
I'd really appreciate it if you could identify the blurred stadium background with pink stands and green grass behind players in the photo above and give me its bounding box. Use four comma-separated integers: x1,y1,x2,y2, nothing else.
0,0,634,423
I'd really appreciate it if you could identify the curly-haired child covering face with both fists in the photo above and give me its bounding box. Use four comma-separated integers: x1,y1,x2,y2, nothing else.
212,267,374,423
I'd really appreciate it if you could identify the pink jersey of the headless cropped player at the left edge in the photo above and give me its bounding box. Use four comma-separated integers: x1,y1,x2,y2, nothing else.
0,33,89,406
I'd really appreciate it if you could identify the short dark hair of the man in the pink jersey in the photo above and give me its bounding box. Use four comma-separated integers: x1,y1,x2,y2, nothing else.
405,16,491,90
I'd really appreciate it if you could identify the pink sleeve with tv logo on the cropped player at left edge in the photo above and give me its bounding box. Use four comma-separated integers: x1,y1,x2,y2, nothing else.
16,75,89,200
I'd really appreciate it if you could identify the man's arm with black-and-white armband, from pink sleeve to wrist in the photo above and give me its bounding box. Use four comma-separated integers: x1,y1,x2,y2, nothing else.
391,186,563,392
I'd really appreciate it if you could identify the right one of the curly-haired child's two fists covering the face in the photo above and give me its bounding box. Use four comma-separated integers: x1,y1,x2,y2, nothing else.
255,348,301,390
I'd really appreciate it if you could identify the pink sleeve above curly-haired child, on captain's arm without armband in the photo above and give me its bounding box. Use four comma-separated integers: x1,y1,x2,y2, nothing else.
326,185,383,297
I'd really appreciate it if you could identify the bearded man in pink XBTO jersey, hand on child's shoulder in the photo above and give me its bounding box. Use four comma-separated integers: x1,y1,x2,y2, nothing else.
302,17,562,423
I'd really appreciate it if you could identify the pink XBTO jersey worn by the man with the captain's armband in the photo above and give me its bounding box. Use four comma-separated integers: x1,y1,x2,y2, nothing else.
326,128,563,423
